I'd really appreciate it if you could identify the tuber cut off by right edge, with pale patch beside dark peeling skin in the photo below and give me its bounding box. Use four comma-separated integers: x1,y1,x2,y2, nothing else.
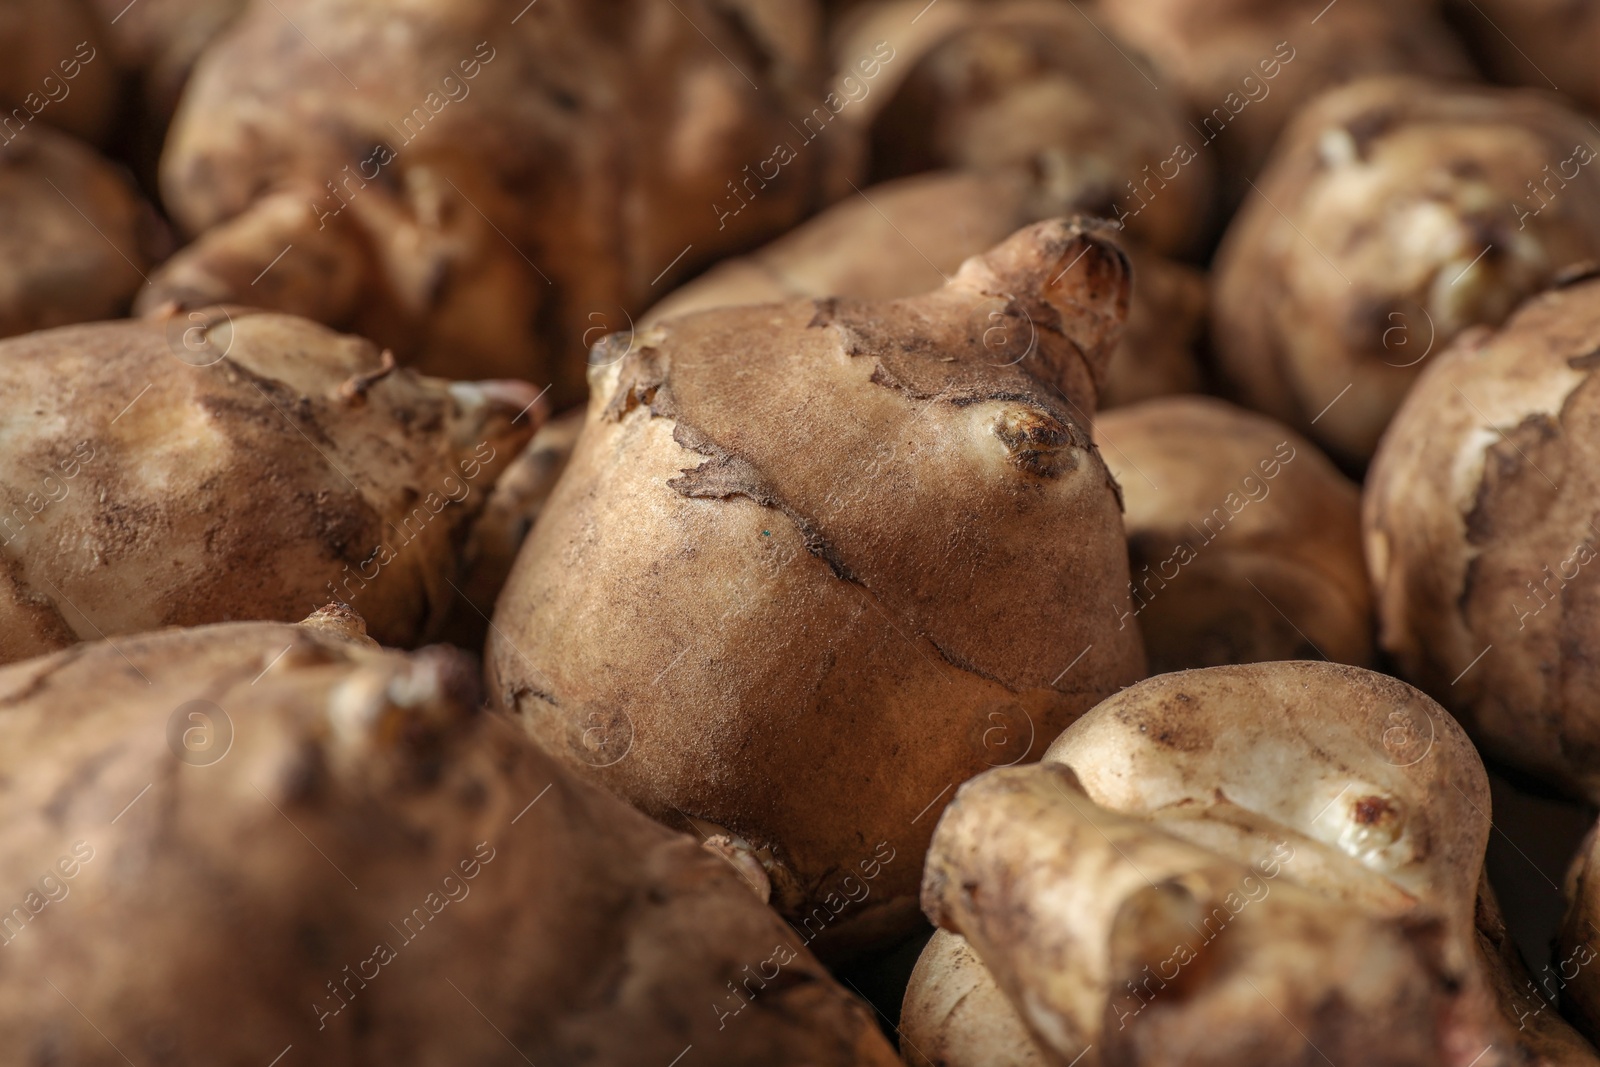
1363,267,1600,800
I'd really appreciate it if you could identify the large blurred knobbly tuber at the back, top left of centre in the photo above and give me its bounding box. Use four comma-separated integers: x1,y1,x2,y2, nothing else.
142,0,850,399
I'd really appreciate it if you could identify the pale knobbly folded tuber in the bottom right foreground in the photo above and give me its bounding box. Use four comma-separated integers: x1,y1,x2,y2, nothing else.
902,662,1597,1067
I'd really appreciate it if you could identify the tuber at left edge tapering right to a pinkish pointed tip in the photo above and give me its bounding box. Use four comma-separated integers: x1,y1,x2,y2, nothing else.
0,309,542,662
